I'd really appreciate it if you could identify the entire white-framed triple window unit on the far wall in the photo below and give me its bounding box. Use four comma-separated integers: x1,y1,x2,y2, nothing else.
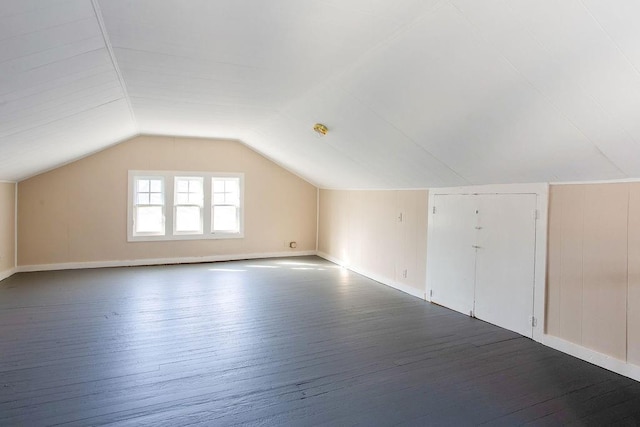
128,171,244,242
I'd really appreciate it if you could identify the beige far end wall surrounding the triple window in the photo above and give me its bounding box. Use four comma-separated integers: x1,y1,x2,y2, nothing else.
18,136,316,266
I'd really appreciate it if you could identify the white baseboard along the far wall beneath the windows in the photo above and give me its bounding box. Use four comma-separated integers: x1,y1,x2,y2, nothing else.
17,251,316,273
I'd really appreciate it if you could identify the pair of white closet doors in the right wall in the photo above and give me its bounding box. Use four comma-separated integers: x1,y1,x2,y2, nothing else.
427,194,536,337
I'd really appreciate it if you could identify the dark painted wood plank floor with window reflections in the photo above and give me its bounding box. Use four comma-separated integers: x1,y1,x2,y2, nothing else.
0,257,640,426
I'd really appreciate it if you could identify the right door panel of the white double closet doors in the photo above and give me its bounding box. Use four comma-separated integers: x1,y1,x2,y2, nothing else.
474,194,536,337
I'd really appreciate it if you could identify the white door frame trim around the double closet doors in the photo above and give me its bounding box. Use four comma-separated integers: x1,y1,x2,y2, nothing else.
425,183,549,342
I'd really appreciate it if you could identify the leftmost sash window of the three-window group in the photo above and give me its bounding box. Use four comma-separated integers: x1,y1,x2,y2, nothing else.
133,177,165,236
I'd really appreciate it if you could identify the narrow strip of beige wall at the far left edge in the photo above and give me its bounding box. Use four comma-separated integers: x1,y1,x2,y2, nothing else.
0,182,16,278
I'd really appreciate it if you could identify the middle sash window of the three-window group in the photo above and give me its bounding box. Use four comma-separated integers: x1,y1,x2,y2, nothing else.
173,176,204,234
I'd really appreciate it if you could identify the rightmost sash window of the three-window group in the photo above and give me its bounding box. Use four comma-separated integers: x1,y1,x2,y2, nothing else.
211,177,240,233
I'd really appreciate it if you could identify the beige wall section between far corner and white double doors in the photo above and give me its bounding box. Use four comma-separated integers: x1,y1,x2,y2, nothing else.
318,190,428,296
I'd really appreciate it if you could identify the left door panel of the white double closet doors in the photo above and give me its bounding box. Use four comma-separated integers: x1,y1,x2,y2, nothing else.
427,194,476,315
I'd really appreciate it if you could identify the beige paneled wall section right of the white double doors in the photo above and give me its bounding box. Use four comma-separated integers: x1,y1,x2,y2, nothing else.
546,183,640,364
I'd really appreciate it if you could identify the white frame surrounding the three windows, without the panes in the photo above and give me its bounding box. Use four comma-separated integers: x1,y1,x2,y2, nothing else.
127,170,244,242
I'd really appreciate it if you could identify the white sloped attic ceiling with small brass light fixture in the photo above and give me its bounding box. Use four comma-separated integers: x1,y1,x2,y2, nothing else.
0,0,640,188
